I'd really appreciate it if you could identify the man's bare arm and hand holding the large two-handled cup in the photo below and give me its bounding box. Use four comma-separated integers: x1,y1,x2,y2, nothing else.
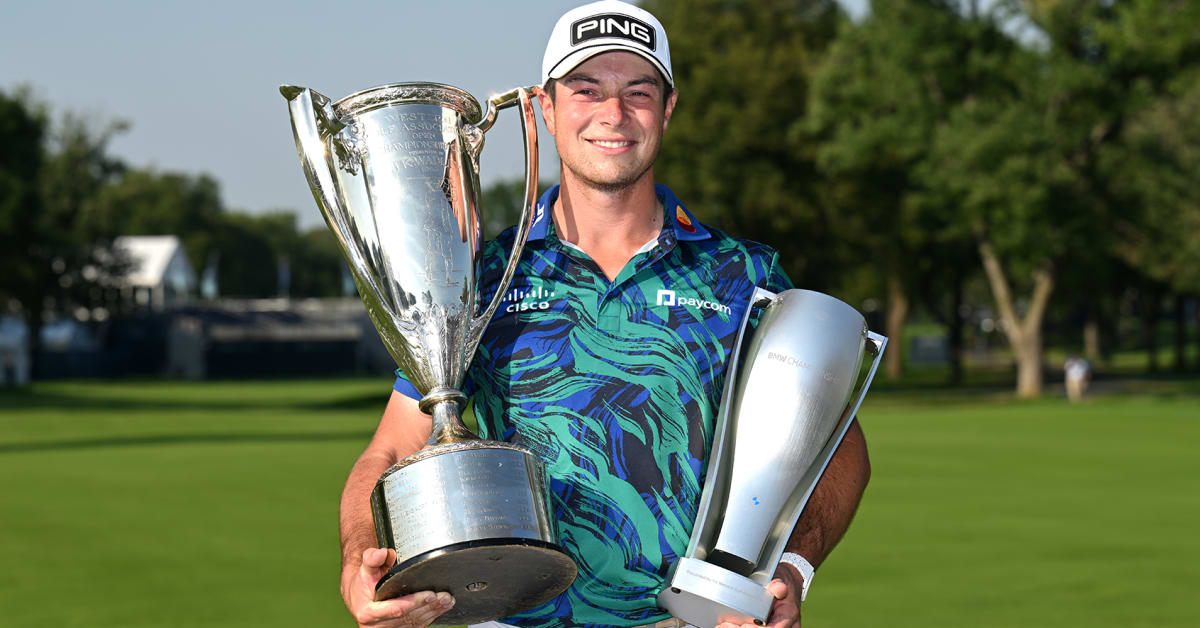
340,390,454,627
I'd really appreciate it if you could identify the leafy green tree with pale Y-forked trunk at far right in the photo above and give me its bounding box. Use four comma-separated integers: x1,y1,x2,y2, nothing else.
907,0,1196,396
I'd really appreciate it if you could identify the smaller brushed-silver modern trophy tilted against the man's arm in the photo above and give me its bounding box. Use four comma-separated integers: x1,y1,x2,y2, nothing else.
658,289,888,627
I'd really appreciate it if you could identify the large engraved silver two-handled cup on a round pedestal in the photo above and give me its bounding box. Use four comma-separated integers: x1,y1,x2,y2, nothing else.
280,83,576,624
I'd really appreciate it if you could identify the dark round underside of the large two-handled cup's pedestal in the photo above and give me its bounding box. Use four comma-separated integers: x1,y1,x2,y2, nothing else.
376,538,576,626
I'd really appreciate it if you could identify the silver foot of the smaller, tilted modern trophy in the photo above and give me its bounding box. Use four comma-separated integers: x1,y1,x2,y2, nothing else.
659,558,775,626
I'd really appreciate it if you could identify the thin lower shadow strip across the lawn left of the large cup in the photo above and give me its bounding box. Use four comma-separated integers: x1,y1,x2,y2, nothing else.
0,430,371,455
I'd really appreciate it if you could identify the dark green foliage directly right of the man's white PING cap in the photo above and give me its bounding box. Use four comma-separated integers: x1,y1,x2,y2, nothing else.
646,0,852,289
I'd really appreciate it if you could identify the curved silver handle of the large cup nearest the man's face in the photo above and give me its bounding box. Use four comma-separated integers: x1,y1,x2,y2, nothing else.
468,86,538,347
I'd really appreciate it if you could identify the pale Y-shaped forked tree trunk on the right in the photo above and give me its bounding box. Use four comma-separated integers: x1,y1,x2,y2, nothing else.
979,237,1054,399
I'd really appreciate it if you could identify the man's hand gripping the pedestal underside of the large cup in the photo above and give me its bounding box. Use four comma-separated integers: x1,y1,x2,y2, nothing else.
342,548,454,628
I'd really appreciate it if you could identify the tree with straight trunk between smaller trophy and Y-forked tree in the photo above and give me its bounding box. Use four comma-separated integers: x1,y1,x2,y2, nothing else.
810,0,1013,377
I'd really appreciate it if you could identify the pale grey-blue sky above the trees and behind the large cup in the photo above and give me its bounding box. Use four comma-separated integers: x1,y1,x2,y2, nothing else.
0,0,866,227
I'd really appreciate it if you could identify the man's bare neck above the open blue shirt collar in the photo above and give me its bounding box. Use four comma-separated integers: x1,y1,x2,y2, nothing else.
553,169,662,266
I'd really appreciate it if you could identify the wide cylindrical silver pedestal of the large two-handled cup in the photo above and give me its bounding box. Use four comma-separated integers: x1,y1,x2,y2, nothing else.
371,441,576,624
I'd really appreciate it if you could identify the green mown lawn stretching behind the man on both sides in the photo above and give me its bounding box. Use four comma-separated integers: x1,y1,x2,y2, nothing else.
0,379,1200,627
